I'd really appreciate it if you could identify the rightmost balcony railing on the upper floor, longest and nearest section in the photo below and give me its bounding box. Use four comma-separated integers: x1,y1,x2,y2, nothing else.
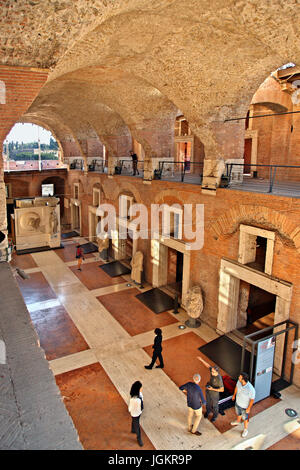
223,163,300,197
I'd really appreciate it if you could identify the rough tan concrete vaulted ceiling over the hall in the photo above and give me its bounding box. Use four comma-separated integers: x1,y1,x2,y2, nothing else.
0,0,300,157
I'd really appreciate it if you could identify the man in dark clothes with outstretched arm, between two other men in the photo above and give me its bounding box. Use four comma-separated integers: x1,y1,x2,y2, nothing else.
197,356,224,423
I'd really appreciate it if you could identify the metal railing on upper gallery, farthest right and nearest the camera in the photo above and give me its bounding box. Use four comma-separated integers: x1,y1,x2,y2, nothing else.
225,163,300,193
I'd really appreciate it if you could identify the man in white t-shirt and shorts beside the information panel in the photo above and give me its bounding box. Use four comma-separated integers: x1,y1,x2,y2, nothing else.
230,372,255,437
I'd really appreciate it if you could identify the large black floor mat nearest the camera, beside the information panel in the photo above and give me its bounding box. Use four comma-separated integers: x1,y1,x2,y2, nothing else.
198,335,255,380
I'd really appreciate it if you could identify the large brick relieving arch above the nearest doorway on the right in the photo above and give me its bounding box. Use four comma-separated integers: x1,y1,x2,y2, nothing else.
209,205,300,253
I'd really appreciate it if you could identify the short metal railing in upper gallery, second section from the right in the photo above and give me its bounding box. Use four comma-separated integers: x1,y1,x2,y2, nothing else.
154,160,203,184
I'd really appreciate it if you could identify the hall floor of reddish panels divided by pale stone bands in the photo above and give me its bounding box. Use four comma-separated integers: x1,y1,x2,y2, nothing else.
5,240,300,450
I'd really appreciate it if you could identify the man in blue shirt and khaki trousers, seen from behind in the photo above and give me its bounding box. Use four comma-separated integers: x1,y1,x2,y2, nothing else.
179,374,206,436
